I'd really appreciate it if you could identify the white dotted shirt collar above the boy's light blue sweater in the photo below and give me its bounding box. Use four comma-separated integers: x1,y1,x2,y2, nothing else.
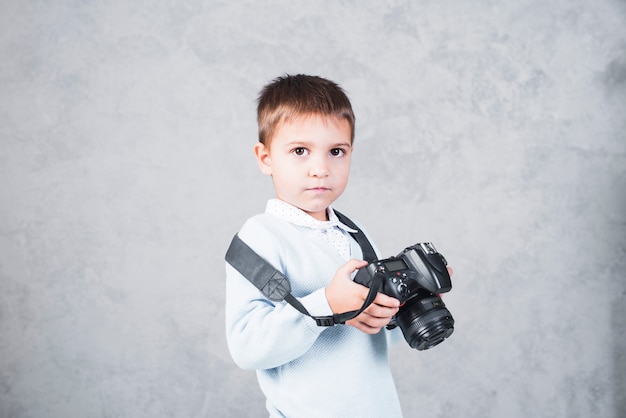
265,199,358,261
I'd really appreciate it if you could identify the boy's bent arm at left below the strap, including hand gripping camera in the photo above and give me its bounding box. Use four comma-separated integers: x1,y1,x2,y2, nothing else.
226,259,400,369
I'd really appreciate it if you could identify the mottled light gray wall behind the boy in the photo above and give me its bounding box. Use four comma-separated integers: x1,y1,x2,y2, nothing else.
0,0,626,418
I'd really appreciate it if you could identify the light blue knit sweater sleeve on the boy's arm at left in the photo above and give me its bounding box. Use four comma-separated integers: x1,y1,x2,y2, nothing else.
225,216,332,369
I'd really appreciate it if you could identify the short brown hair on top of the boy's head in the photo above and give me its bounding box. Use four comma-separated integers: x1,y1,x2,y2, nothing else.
257,74,355,147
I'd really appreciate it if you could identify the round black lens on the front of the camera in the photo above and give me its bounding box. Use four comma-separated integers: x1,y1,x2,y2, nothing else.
396,293,454,351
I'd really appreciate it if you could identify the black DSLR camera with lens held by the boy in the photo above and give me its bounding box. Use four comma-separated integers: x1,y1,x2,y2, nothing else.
354,242,454,351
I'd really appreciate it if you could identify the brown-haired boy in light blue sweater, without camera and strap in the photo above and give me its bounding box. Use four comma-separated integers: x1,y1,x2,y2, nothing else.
226,75,401,418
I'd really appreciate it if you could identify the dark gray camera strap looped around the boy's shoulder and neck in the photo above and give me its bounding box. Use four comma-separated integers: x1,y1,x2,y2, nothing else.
226,211,382,327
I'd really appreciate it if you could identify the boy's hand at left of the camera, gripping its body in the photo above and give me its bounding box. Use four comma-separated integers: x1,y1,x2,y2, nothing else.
326,259,400,334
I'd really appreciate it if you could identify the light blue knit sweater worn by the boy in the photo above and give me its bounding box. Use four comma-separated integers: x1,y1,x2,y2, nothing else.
225,213,402,418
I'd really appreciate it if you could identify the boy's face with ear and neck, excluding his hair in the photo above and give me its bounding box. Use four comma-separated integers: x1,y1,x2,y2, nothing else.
254,115,352,221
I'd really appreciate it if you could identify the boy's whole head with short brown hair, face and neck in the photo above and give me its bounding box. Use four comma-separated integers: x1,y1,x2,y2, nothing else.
254,75,354,221
